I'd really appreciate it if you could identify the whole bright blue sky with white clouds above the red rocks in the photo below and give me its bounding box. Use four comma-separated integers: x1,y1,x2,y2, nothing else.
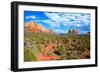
24,11,90,34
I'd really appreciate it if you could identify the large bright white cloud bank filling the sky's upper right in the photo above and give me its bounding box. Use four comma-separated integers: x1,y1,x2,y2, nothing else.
45,12,90,27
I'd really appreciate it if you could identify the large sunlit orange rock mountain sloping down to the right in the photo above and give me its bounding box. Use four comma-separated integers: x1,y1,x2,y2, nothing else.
25,22,54,34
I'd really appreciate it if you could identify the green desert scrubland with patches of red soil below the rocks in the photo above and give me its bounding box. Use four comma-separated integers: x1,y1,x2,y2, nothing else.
24,32,90,62
